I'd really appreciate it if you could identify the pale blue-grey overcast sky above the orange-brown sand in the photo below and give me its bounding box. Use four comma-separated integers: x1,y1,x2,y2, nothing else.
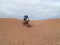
0,0,60,20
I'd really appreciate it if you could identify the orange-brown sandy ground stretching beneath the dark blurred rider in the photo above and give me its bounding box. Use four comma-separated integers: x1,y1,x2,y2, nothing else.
0,18,60,45
